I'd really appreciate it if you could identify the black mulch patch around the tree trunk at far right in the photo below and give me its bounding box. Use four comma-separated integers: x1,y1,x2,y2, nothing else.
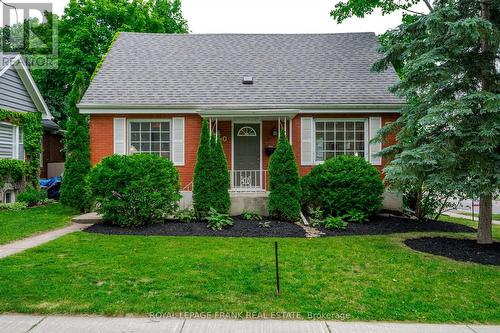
405,237,500,266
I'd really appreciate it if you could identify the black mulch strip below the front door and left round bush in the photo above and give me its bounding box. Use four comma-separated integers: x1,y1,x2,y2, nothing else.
85,218,305,237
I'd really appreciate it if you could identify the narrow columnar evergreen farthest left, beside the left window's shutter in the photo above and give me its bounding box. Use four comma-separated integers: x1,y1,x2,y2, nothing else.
193,119,214,218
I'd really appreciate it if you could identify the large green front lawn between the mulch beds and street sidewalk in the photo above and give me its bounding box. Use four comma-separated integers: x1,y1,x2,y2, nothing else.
0,215,500,323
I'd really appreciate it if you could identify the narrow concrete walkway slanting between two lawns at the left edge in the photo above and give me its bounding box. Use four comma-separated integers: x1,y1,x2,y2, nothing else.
0,223,89,260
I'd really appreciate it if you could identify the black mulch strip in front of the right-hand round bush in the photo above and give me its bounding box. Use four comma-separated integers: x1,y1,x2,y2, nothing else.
317,214,476,236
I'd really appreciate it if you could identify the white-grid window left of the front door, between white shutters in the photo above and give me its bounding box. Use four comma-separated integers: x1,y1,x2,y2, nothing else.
129,120,171,159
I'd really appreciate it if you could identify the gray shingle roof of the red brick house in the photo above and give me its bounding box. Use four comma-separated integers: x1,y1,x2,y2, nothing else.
81,33,402,106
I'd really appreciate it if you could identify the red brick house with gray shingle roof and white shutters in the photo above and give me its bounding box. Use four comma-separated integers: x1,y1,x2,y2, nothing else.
79,33,404,212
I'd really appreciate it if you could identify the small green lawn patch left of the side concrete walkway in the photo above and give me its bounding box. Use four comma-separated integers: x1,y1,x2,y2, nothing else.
0,204,77,244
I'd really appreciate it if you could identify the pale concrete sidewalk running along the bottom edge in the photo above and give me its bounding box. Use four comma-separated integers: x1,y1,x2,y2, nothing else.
0,315,500,333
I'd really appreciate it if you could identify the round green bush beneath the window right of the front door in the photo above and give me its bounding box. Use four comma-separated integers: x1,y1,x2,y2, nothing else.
301,155,384,216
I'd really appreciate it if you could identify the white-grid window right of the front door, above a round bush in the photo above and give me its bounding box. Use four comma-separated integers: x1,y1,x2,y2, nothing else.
315,119,367,162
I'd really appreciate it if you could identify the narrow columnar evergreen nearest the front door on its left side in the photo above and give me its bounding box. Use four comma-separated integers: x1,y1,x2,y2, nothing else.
211,135,231,214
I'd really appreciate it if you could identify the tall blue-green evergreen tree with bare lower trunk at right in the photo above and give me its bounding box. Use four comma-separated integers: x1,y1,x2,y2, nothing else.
375,0,500,243
